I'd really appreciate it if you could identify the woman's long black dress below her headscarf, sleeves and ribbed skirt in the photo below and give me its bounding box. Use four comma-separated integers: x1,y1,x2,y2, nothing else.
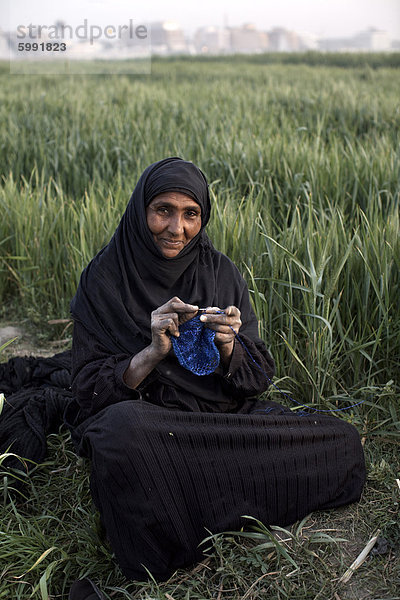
65,324,365,579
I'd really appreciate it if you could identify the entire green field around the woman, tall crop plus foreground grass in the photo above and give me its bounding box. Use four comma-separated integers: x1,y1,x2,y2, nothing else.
0,54,400,600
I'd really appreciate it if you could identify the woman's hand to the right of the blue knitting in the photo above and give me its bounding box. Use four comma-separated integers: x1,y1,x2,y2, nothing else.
200,306,242,365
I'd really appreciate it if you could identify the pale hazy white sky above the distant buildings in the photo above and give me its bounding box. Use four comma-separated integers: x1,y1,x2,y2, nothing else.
0,0,400,39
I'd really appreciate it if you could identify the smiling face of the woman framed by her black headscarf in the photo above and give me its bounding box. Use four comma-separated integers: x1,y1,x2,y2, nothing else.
146,192,201,258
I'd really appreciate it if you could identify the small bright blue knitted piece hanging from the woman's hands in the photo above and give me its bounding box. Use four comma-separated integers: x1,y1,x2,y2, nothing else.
171,315,219,375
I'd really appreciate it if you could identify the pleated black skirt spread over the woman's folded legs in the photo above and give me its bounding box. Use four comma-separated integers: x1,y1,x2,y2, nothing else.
81,401,365,580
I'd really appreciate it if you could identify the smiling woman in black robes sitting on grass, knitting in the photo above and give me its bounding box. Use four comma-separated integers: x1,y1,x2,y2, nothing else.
68,158,365,579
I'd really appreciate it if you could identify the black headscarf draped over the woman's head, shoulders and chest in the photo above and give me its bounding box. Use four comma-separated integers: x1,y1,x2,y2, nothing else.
71,157,257,388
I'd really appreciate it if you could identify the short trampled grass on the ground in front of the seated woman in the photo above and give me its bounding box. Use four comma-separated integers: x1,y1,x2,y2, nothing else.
0,432,400,600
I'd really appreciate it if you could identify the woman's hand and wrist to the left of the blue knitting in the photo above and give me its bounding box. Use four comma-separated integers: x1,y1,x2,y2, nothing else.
150,296,199,360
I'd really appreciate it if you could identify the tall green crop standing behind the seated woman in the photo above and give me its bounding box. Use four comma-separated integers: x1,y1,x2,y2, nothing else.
0,57,400,407
